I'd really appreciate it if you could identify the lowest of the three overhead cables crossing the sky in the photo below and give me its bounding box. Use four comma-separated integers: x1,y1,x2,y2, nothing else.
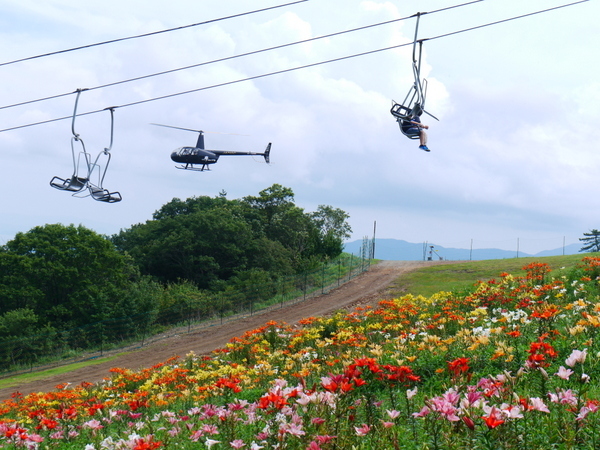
0,0,589,133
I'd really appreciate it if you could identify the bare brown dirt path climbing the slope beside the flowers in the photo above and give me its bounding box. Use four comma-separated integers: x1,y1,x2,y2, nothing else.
0,261,447,401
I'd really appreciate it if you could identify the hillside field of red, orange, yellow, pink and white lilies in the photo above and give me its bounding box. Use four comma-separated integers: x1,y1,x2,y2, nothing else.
0,257,600,450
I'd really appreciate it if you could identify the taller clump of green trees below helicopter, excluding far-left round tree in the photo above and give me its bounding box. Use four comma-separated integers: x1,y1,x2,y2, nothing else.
112,184,350,290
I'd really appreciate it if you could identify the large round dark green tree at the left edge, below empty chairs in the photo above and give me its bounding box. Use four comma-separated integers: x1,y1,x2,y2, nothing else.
0,224,137,329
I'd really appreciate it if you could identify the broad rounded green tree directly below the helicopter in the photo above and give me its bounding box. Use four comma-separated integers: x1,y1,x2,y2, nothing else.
113,197,254,288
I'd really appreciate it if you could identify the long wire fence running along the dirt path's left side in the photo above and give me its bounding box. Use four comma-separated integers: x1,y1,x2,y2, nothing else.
0,249,371,378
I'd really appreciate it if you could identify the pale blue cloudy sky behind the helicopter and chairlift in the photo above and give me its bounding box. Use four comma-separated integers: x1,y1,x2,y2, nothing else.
0,0,600,254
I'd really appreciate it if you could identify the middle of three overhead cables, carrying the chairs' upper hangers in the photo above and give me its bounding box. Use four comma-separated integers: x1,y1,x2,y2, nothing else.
0,0,483,110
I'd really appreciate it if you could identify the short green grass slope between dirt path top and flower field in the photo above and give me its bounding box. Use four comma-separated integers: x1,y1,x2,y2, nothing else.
391,253,600,297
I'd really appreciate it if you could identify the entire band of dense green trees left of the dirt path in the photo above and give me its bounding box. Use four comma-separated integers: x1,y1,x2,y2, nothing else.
0,184,351,370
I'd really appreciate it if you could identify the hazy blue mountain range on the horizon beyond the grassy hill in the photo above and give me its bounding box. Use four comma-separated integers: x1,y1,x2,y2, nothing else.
344,239,581,261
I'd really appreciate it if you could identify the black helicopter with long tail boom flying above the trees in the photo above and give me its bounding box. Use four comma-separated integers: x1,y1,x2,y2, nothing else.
152,123,271,172
